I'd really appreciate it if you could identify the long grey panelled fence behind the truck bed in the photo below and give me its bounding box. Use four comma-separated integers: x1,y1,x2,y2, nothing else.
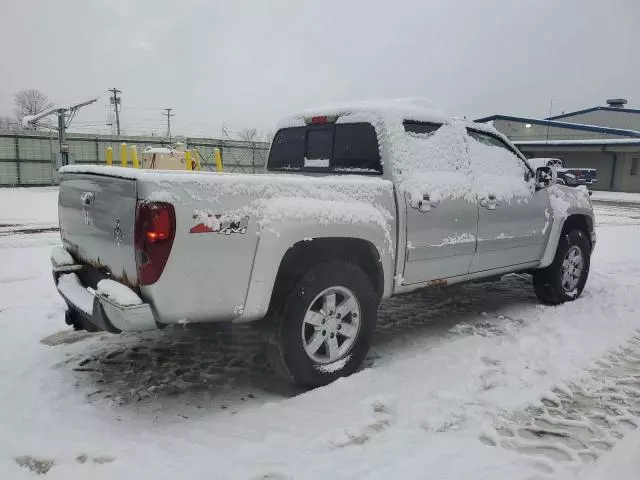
0,131,269,186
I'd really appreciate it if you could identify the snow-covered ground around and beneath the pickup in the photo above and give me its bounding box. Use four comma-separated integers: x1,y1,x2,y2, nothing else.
0,189,640,480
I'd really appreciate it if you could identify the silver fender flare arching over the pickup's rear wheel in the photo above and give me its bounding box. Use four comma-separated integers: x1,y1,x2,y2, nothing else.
235,219,394,322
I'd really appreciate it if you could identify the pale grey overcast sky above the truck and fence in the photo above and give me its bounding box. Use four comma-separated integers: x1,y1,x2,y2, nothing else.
0,0,640,136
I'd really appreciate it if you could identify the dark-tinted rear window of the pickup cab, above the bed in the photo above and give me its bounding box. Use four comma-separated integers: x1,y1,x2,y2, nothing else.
267,123,382,175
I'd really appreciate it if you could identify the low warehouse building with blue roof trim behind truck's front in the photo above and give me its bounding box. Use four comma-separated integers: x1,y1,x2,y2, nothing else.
476,99,640,192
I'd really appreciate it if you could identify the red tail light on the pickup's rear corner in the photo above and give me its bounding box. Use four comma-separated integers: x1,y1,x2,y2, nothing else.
135,202,176,285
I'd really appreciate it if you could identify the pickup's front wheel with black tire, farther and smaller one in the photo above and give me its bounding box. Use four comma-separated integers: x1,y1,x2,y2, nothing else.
533,229,591,305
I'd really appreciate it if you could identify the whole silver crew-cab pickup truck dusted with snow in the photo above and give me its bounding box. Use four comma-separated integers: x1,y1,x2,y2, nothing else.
51,102,596,387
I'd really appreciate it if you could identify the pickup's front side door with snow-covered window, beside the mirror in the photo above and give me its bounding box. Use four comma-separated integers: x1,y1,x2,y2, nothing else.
467,130,550,273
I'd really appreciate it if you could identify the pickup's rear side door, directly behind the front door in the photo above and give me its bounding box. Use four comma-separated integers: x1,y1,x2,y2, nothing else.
403,121,478,285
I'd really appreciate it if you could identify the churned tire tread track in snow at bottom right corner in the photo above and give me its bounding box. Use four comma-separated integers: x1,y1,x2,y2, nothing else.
479,331,640,475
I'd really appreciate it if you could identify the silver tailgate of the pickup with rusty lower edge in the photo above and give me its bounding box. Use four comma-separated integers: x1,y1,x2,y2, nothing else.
58,173,138,287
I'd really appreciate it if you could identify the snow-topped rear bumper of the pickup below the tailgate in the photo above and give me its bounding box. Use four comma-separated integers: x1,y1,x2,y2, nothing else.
51,247,158,333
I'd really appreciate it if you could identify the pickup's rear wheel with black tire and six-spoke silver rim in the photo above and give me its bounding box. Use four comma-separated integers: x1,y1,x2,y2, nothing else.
269,261,378,388
